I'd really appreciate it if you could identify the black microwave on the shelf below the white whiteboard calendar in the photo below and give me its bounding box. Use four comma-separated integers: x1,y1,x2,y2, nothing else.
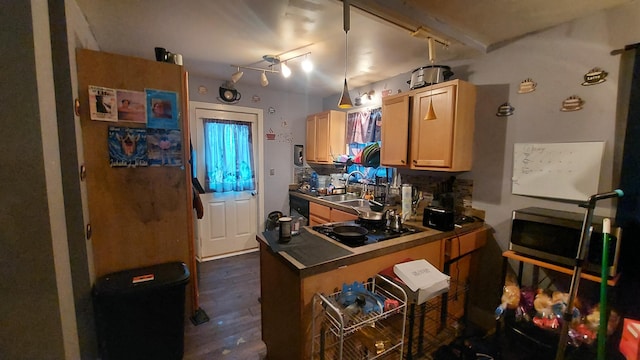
509,207,622,277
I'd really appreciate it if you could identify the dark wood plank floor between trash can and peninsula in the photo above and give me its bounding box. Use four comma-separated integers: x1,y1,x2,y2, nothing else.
184,252,267,360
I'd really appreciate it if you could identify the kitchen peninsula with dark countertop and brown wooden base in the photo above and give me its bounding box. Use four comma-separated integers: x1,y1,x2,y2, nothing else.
256,210,488,359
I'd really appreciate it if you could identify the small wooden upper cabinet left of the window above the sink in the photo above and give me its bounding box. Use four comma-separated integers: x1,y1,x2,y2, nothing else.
306,110,347,164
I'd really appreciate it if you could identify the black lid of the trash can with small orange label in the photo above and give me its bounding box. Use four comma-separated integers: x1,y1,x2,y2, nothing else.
94,262,190,296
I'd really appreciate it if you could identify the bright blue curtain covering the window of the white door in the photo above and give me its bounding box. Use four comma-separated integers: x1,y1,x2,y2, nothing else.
204,119,255,192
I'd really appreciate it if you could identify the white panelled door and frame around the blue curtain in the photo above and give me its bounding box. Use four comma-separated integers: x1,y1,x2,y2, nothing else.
189,101,264,261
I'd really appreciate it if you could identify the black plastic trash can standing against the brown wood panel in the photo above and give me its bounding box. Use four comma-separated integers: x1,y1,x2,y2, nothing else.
93,262,190,360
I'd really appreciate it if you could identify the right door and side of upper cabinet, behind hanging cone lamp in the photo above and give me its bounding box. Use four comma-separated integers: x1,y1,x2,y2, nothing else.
409,80,476,171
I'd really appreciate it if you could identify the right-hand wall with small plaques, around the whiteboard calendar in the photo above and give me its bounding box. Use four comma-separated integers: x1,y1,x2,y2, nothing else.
465,9,633,249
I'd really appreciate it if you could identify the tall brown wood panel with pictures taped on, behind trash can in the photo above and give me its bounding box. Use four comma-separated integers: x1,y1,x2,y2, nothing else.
76,49,195,307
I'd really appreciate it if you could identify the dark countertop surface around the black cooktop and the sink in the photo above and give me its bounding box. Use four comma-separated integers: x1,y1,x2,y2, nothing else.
256,192,486,277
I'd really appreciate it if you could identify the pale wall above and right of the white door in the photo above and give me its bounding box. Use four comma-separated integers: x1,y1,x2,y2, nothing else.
189,75,322,220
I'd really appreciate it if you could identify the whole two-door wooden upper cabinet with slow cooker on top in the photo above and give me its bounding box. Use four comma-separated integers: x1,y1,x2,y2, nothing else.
380,80,476,171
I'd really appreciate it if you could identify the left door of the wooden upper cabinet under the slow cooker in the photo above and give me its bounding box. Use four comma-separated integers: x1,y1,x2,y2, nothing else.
380,93,410,167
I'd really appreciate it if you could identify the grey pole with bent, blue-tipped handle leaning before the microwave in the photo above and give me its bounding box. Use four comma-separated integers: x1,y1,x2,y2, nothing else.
555,189,624,360
